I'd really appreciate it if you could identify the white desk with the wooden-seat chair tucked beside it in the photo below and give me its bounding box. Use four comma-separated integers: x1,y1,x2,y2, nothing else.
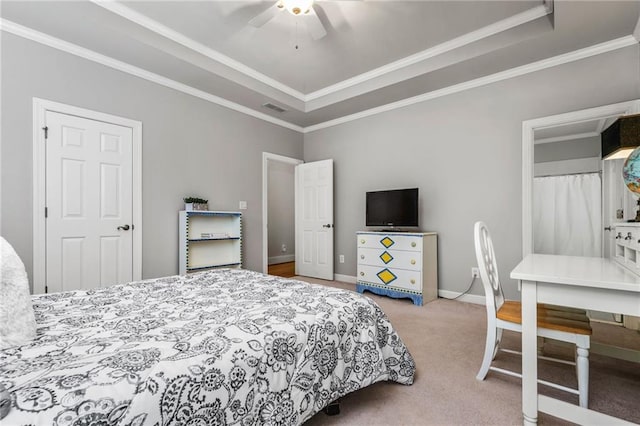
511,254,640,425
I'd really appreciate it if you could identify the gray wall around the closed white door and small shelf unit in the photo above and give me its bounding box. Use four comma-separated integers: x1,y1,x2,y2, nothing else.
0,32,303,286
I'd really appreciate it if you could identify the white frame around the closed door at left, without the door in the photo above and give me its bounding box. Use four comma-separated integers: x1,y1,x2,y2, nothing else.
33,97,142,294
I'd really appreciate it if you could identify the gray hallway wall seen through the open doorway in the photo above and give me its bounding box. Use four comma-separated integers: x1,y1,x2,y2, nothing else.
267,161,296,264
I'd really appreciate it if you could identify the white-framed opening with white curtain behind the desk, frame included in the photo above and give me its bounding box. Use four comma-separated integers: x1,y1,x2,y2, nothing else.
522,100,640,323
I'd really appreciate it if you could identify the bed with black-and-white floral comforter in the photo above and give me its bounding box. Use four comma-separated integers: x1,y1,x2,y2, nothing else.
0,269,415,426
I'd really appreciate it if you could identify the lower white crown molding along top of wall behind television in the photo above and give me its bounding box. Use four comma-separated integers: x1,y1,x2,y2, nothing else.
303,35,638,133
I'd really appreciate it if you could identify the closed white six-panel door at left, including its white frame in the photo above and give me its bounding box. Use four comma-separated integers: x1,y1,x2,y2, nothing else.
33,98,142,293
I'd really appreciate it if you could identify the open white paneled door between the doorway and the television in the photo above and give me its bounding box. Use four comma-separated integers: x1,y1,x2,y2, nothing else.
295,160,333,280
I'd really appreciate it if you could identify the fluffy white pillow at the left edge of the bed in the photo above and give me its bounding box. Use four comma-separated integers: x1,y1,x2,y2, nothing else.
0,237,36,349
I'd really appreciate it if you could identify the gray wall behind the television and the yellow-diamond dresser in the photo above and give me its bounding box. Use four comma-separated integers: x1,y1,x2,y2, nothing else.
304,45,640,298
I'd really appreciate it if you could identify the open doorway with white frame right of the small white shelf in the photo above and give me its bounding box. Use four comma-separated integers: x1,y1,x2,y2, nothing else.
262,152,303,277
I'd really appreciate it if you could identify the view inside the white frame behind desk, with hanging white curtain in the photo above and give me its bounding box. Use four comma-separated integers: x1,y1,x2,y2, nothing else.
532,117,616,257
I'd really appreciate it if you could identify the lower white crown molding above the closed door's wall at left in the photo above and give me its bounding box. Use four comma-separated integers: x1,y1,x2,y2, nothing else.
0,18,303,132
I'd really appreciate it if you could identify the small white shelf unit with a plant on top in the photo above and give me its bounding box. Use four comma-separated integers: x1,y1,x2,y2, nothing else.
178,211,242,275
